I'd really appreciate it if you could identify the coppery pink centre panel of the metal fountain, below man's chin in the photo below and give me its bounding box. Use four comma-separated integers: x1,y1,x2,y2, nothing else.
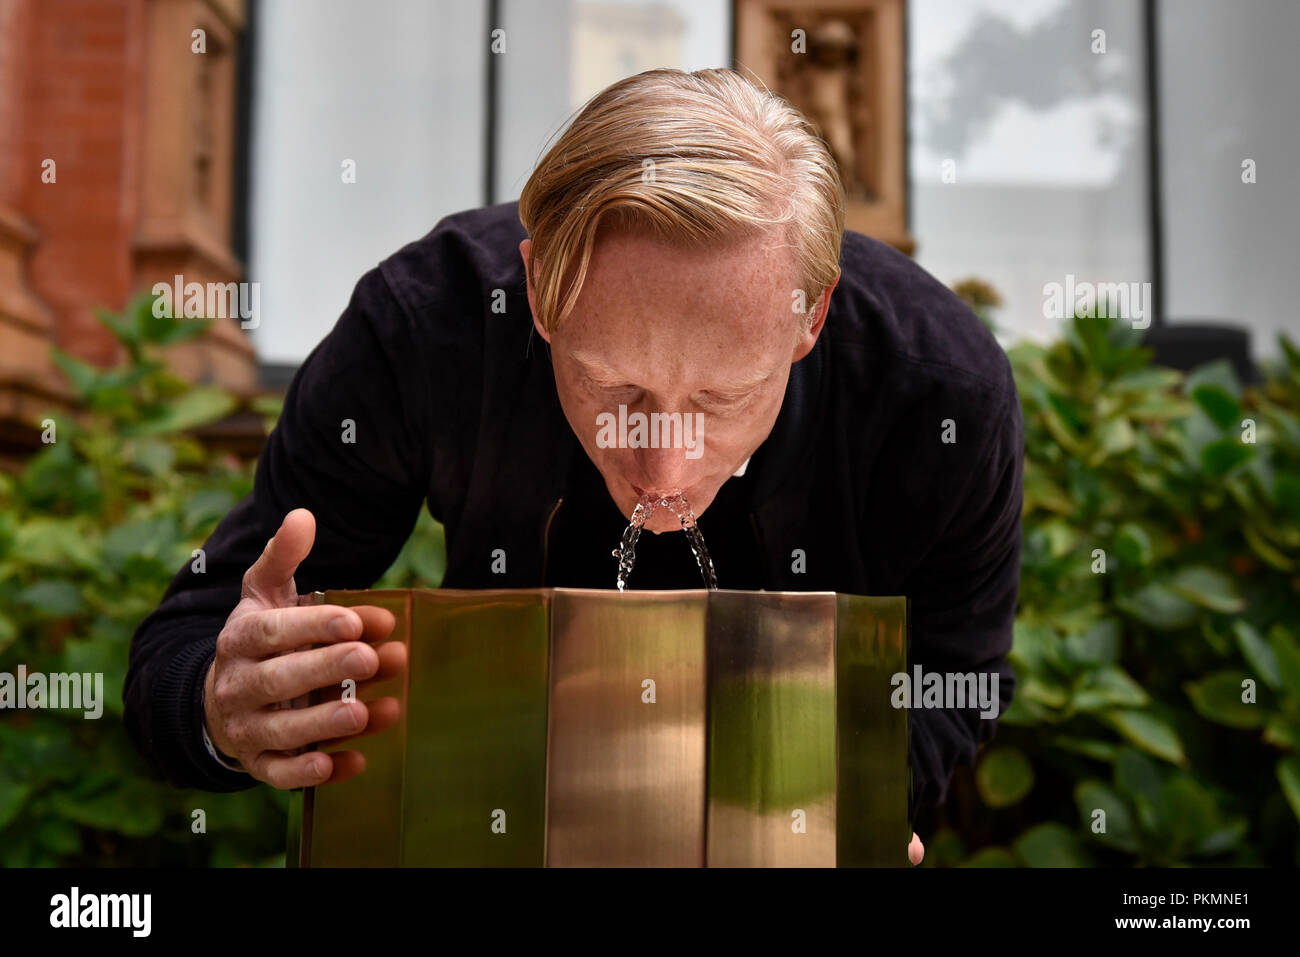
546,589,709,867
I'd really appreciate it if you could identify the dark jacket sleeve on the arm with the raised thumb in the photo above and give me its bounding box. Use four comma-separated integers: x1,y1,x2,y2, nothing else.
122,269,432,791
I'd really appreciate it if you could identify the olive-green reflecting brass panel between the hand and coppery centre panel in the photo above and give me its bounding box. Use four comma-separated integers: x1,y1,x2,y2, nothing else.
402,590,547,867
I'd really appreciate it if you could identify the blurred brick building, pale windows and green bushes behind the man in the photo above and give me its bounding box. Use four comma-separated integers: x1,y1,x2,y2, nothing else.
0,0,1300,866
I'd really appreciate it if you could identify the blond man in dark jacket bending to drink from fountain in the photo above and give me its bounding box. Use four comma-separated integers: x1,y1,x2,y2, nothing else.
125,70,1023,862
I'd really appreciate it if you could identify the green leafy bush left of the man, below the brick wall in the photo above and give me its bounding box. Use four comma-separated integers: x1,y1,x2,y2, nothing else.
0,299,287,867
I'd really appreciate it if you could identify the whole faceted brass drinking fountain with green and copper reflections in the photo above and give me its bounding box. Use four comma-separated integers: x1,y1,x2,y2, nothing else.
286,589,910,866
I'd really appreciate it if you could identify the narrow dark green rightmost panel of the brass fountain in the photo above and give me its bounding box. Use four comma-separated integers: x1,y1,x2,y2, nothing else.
836,594,911,867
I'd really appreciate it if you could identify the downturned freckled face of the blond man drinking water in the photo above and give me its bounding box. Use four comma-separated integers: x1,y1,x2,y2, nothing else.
520,231,833,533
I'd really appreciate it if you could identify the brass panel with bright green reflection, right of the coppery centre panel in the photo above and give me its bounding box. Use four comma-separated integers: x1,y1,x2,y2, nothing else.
709,592,836,867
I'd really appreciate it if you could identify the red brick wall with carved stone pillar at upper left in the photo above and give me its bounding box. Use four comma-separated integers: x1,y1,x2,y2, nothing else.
0,0,257,460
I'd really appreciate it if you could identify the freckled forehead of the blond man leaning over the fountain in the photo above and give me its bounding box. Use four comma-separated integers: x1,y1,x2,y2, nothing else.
559,222,798,373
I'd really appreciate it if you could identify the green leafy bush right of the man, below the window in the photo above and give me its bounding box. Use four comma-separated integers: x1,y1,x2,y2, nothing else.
927,317,1300,866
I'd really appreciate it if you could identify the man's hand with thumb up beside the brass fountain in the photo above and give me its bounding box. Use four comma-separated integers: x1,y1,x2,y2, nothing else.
204,508,406,788
